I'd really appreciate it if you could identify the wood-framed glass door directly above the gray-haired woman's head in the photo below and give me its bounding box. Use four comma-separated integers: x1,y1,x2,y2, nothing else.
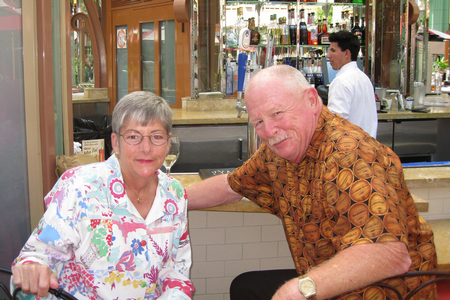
112,5,185,107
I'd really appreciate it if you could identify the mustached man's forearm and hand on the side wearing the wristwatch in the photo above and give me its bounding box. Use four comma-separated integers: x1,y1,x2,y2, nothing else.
273,242,411,300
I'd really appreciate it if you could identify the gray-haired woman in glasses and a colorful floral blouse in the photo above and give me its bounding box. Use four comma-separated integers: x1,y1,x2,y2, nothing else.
12,92,194,299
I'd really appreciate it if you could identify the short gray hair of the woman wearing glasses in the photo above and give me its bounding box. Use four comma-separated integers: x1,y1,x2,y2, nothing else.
112,91,172,134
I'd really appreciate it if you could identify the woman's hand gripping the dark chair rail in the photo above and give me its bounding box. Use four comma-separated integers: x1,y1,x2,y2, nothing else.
12,263,59,297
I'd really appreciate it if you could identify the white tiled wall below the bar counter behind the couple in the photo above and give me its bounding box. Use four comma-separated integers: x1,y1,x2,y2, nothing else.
189,187,450,300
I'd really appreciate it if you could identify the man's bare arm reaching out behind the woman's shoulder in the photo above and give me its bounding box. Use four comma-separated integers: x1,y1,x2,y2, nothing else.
186,174,242,210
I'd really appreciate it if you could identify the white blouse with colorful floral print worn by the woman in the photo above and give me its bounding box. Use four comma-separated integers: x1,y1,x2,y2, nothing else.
14,155,194,300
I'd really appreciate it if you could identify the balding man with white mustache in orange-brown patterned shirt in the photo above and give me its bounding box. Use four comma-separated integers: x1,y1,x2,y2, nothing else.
187,66,437,300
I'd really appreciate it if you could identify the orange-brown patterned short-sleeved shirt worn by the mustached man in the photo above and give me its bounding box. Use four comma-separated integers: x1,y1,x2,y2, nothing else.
228,107,437,299
